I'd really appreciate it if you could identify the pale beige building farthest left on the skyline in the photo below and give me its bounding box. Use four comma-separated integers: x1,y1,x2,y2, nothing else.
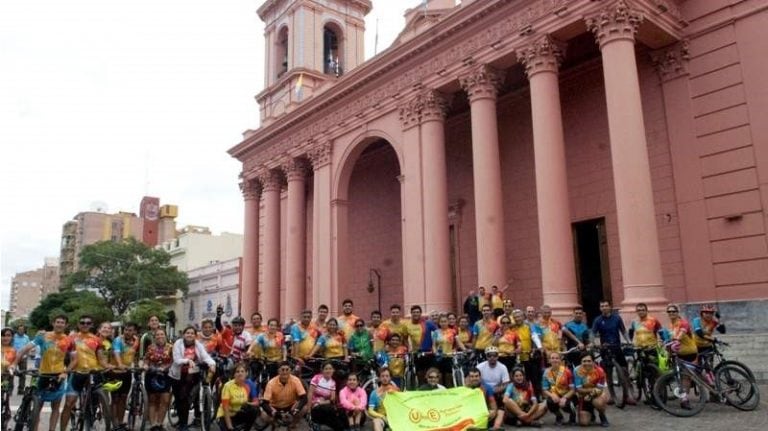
9,257,59,319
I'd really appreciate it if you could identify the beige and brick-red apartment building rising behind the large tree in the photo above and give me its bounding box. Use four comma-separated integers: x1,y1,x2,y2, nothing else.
59,196,178,283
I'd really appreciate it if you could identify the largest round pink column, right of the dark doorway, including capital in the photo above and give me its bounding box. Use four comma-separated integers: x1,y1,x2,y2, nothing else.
586,0,667,307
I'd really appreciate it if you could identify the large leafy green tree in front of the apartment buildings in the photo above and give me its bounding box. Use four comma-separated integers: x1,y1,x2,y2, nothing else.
65,238,188,316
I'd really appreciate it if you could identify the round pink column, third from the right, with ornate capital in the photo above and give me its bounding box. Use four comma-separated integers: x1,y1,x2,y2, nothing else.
460,65,507,289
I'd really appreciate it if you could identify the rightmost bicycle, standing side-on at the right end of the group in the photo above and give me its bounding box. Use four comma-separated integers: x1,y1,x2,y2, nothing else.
653,343,760,417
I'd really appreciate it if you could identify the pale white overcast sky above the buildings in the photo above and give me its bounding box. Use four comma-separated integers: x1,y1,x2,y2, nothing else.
0,0,421,309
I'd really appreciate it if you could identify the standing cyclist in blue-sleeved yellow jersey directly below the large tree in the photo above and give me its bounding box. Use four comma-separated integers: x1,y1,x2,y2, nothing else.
111,322,139,428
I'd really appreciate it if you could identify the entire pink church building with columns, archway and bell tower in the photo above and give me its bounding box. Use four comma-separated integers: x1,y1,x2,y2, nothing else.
229,0,768,329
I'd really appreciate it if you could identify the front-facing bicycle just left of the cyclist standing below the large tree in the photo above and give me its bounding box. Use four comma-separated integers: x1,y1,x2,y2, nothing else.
70,371,113,431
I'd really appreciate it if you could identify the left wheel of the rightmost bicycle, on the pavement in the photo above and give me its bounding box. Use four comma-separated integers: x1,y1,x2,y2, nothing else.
653,372,709,417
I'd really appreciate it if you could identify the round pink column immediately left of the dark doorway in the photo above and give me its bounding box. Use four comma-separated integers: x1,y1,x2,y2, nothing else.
517,36,578,316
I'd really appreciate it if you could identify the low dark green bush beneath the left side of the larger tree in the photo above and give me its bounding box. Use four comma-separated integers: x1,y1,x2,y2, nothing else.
29,289,115,330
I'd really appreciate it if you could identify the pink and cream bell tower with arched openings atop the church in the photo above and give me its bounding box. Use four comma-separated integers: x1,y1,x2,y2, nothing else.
256,0,372,125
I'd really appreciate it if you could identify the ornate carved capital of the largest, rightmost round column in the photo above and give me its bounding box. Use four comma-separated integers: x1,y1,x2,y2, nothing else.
585,0,645,49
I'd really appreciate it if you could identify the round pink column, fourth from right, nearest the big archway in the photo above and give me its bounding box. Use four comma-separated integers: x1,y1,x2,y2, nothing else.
419,90,455,311
